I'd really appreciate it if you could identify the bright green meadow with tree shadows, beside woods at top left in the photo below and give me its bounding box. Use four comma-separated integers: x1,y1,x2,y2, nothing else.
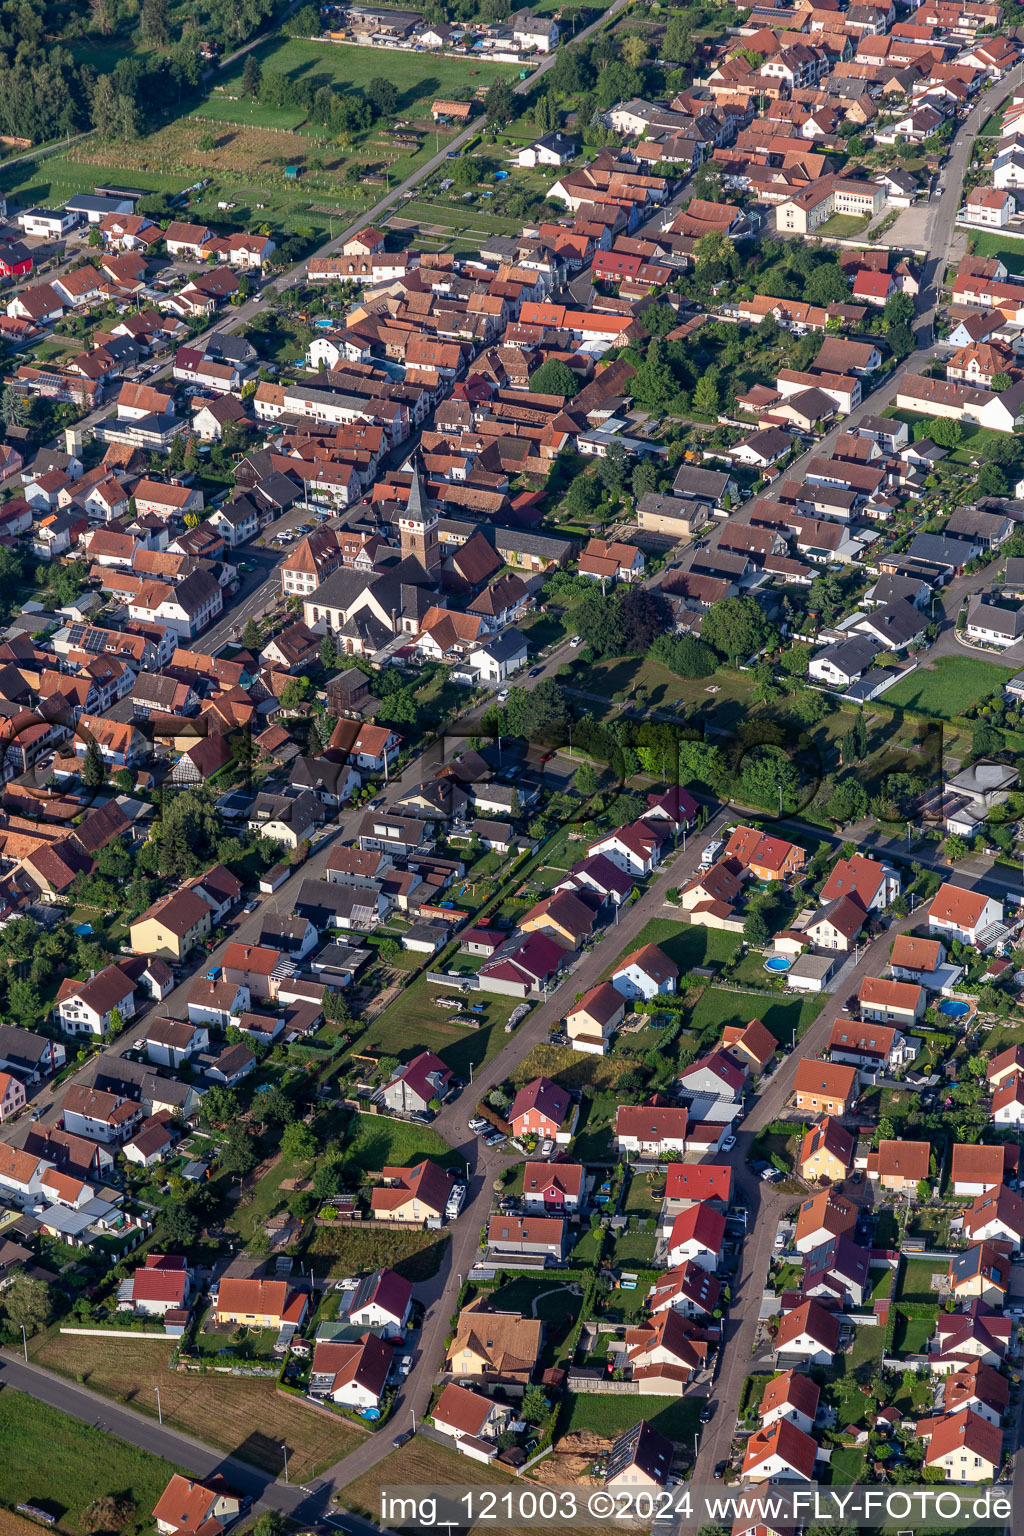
218,37,519,118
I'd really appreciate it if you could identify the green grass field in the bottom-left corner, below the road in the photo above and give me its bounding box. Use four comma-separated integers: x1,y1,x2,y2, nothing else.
0,1387,178,1536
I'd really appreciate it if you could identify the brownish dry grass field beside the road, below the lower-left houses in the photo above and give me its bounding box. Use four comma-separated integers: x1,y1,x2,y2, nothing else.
28,1332,362,1480
